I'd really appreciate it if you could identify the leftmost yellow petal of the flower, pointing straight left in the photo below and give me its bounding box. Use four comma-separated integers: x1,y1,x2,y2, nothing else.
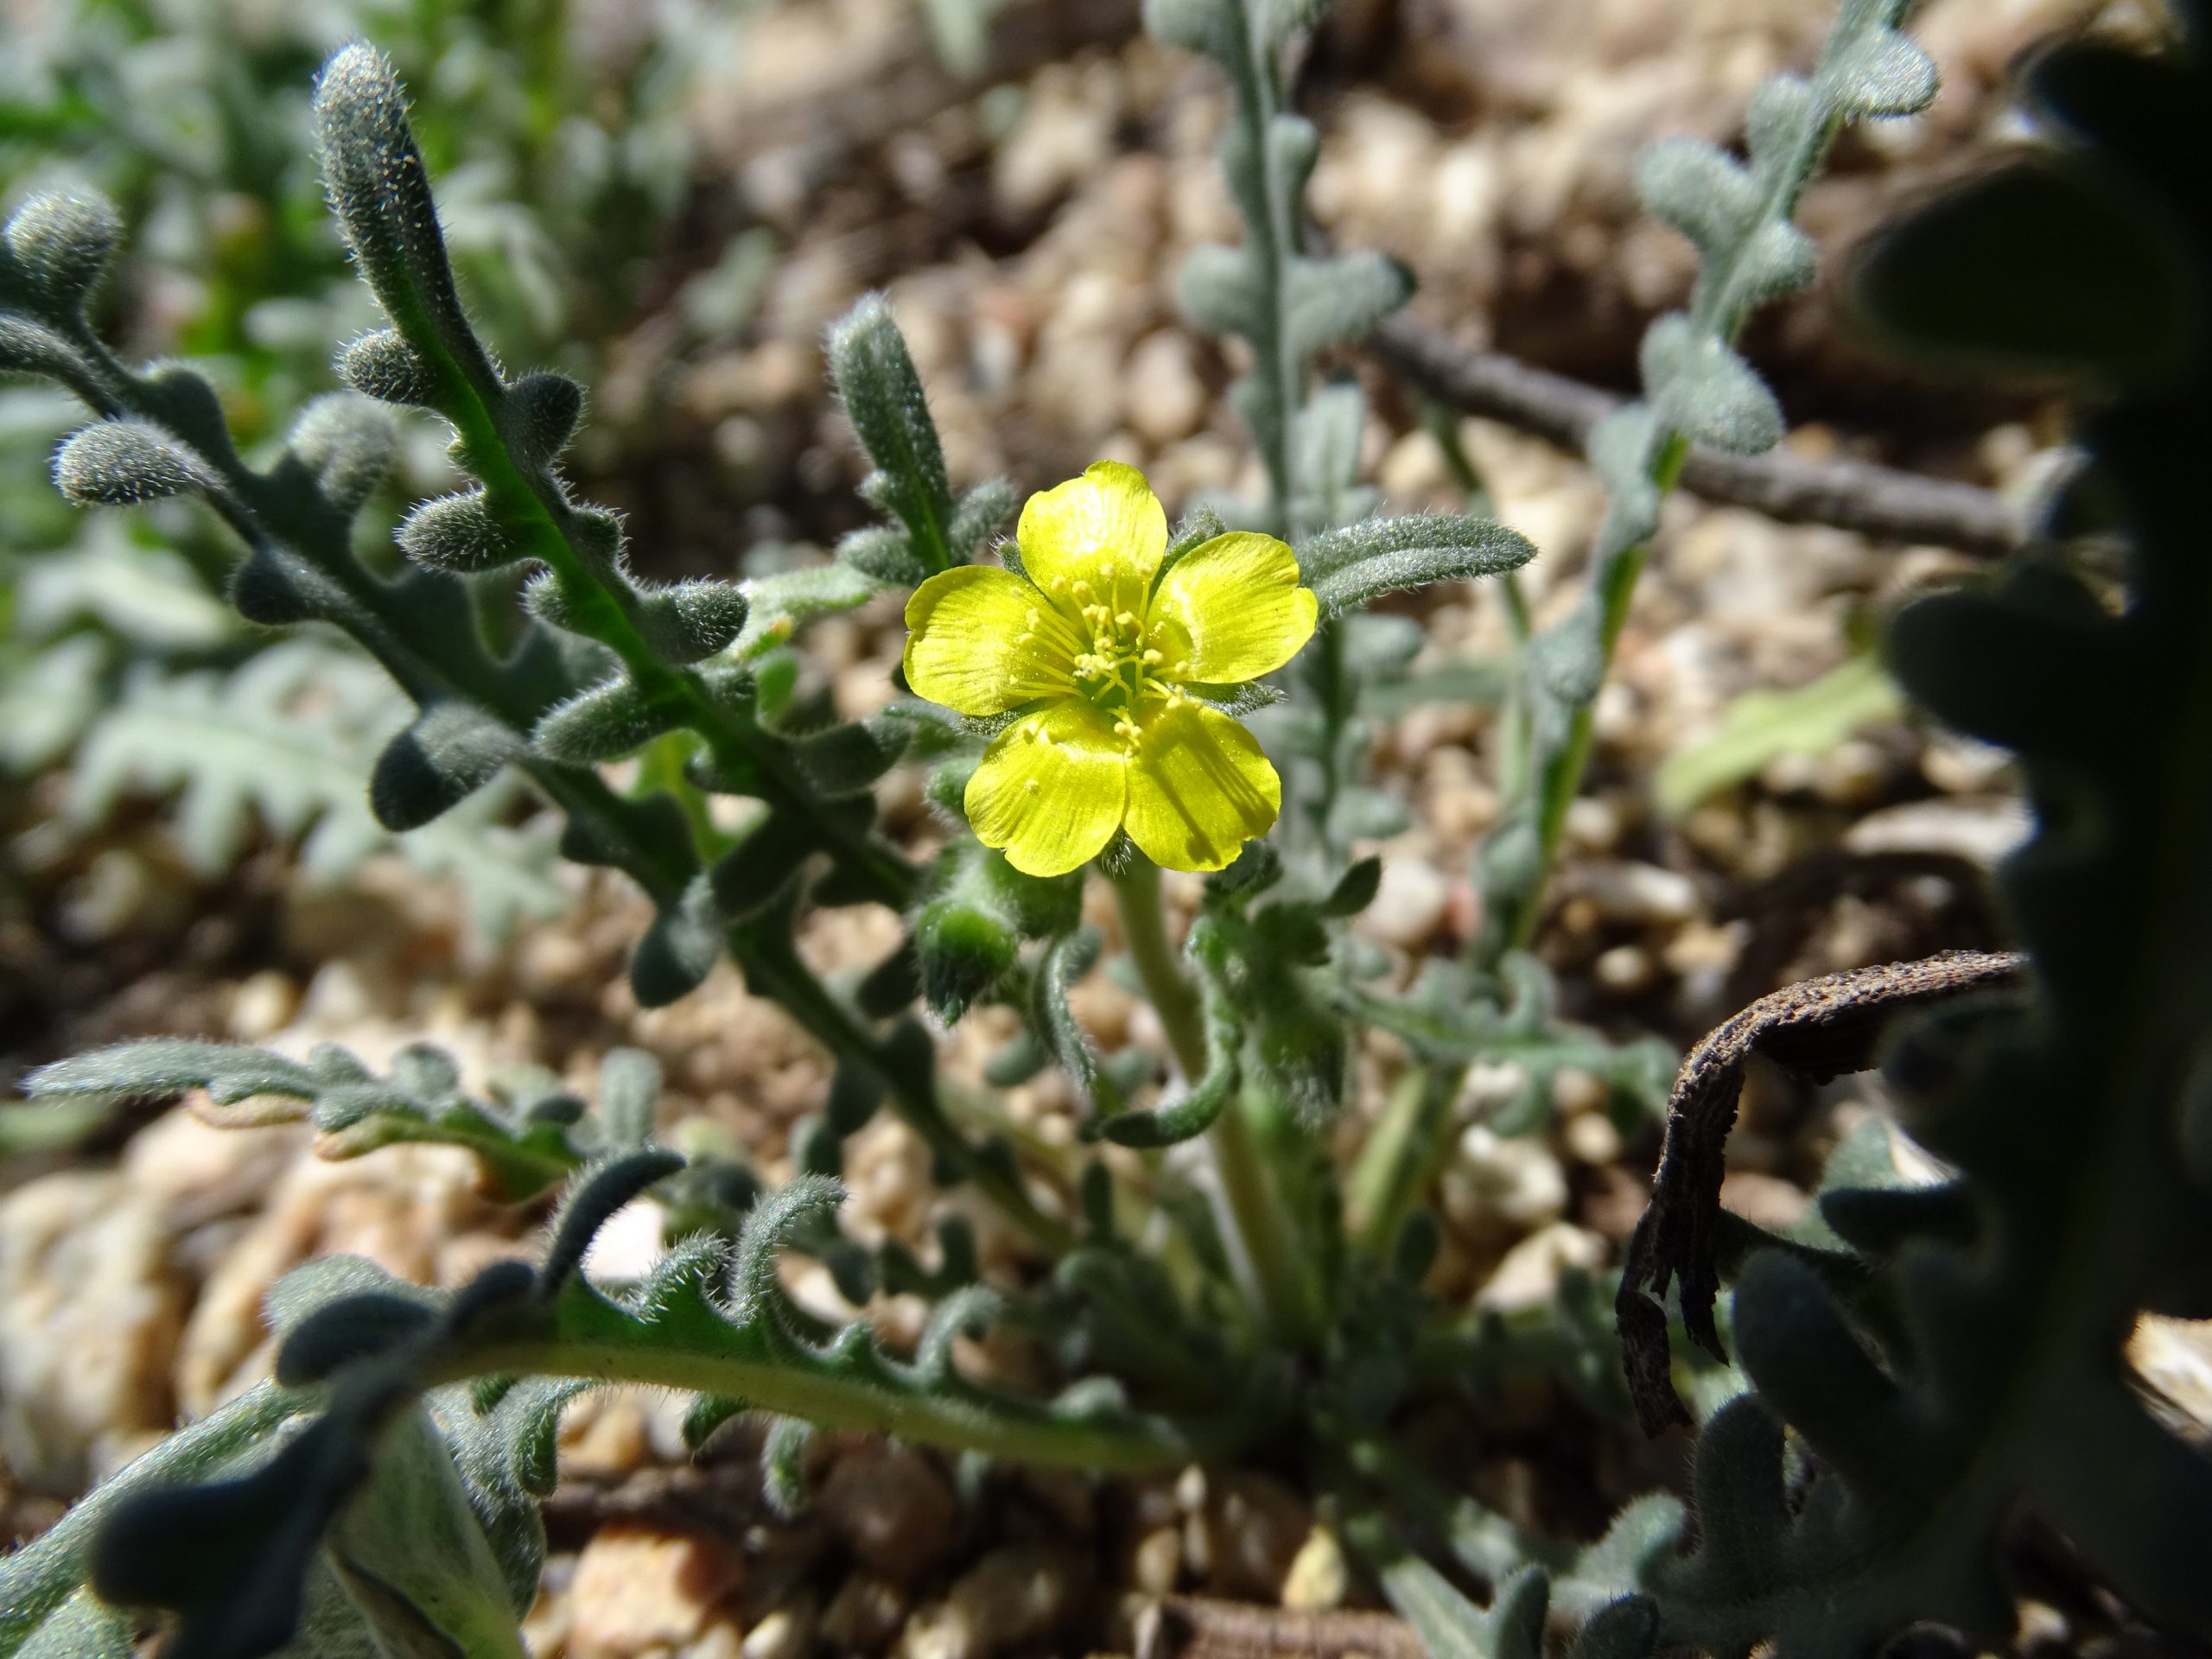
907,564,1077,715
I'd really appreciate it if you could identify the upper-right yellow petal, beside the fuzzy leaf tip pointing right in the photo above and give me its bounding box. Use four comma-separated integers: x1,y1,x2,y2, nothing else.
1150,531,1319,686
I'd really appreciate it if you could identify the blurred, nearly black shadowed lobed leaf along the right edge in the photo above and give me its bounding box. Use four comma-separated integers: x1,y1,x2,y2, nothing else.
1618,7,2212,1659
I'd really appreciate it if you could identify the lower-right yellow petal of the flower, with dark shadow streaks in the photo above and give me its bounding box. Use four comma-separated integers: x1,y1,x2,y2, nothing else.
1128,696,1283,869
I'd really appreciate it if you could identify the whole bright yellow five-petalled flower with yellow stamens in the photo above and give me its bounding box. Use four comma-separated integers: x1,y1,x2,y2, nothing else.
907,460,1316,876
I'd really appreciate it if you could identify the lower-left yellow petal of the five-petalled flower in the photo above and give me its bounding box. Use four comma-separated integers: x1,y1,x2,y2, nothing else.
964,699,1128,876
